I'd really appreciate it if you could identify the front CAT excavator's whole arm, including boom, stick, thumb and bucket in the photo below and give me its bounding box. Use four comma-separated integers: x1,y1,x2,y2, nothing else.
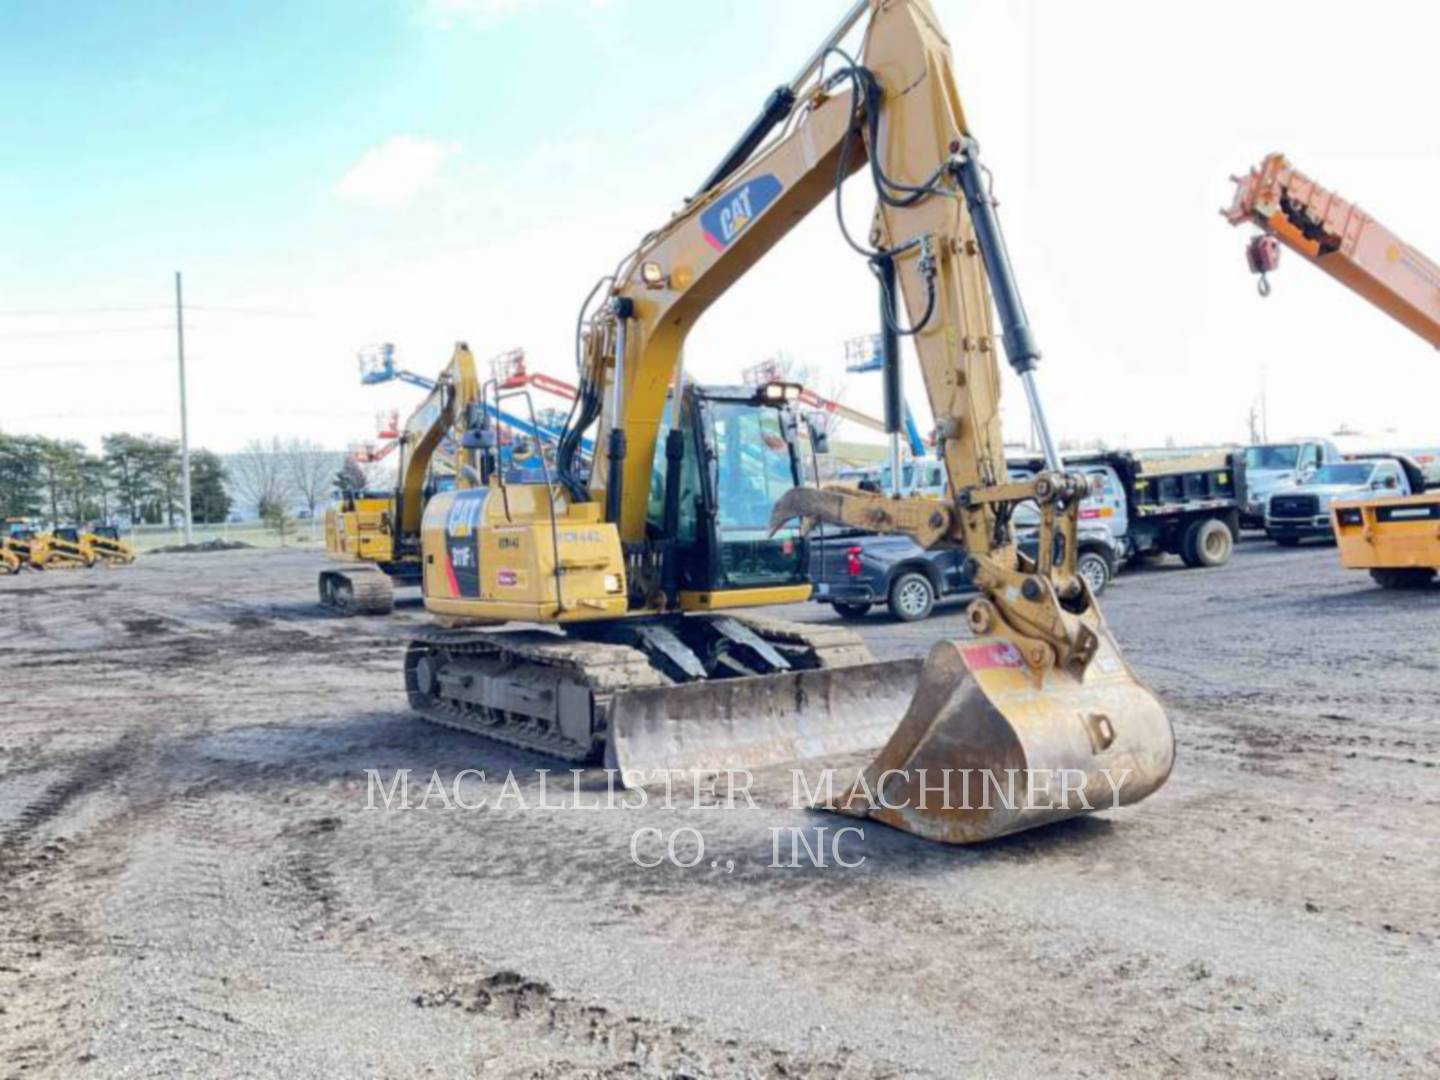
560,0,1174,842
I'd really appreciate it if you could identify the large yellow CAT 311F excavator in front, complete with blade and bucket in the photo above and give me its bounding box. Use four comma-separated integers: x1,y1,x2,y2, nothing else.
405,0,1174,842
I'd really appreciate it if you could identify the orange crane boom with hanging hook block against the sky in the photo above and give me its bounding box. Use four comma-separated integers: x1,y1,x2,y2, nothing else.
1221,154,1440,348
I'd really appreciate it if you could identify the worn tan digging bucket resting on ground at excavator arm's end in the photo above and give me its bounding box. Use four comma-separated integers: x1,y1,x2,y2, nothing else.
829,626,1175,844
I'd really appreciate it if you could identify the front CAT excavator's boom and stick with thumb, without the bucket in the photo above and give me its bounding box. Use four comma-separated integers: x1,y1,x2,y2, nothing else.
573,0,1099,685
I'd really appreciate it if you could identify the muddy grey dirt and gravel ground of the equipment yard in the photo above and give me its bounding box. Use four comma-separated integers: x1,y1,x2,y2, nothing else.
0,541,1440,1077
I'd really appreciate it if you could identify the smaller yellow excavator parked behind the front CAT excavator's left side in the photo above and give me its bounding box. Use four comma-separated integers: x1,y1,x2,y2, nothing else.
320,343,480,615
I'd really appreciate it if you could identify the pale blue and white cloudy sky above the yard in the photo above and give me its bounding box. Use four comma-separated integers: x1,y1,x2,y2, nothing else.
0,0,1440,451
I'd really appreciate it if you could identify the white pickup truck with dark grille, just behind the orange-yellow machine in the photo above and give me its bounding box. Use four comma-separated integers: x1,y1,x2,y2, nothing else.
1264,455,1426,547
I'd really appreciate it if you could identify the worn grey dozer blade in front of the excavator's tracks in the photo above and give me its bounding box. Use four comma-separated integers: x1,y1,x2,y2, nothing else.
605,660,920,788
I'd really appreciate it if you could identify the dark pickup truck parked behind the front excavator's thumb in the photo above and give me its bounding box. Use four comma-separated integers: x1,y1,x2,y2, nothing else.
808,523,1120,622
